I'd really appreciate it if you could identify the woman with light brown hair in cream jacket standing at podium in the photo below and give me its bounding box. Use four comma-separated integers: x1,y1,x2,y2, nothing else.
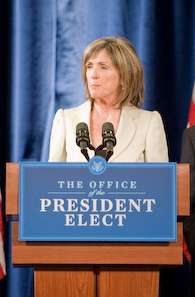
49,37,168,162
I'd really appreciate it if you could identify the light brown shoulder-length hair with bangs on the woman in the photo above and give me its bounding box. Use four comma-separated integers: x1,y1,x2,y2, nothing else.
82,37,144,106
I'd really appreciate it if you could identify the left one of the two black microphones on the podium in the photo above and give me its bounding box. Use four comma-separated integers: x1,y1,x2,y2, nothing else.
76,122,90,161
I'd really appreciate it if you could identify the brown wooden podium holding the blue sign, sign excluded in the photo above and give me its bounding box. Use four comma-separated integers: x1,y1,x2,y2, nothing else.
6,163,190,297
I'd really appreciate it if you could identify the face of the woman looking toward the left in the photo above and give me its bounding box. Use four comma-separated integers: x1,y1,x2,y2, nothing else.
86,49,121,104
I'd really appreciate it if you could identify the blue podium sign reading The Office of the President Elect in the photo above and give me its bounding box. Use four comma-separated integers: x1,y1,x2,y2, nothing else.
19,157,176,242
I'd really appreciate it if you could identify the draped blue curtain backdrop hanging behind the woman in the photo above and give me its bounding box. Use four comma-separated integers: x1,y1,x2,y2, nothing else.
0,0,195,297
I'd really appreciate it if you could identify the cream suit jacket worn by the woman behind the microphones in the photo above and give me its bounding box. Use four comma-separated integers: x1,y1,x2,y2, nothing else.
49,101,168,162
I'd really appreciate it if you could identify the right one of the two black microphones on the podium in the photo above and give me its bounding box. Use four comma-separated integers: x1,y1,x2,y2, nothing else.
102,122,116,160
